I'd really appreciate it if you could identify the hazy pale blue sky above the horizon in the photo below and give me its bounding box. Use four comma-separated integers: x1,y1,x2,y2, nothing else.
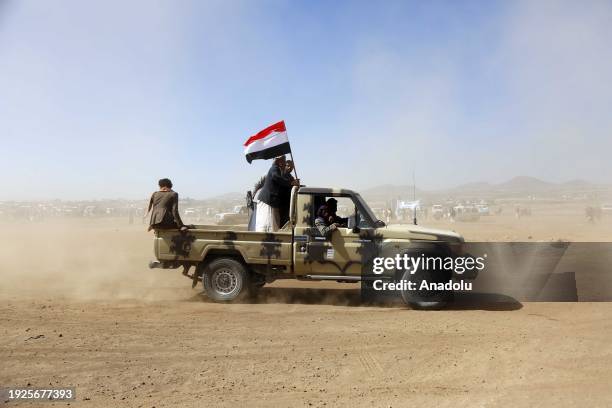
0,0,612,199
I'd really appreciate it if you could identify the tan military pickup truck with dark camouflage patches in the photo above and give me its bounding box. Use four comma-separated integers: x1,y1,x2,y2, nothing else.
149,186,465,309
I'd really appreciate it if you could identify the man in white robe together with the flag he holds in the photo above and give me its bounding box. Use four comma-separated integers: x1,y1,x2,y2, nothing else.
244,121,300,232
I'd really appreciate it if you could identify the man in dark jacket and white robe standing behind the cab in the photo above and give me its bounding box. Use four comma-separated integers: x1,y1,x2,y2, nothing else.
255,156,300,232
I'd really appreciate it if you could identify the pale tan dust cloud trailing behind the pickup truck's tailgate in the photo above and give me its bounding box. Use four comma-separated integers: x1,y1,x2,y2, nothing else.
0,219,189,300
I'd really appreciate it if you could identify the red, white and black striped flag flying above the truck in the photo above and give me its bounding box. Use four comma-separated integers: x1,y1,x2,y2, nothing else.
244,120,291,163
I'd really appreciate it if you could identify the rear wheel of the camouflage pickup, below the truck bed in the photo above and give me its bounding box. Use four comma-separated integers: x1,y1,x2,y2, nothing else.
202,258,249,302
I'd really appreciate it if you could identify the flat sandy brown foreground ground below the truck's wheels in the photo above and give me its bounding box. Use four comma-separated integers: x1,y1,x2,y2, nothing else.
0,299,612,407
